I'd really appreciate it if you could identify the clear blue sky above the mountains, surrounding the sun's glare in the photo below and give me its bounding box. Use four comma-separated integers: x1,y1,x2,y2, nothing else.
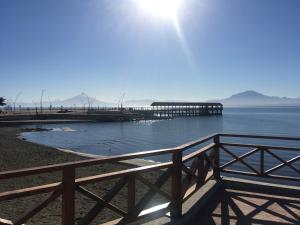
0,0,300,101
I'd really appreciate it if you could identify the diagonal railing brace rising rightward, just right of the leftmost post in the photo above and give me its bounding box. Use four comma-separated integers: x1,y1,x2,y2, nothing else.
77,177,127,225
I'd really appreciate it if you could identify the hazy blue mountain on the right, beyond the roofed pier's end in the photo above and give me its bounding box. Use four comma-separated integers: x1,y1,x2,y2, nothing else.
214,91,300,107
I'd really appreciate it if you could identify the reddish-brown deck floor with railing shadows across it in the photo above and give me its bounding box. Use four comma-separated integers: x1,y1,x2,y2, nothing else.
193,179,300,225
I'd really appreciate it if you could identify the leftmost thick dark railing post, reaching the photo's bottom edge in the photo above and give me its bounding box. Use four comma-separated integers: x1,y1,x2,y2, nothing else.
62,167,75,225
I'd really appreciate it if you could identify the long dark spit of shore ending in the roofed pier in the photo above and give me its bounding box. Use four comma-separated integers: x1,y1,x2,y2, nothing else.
0,102,223,125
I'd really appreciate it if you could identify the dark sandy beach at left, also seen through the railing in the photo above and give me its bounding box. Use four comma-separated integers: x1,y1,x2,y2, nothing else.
0,127,170,225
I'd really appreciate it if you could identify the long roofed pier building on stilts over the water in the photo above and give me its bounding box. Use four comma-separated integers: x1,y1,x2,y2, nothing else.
151,102,223,118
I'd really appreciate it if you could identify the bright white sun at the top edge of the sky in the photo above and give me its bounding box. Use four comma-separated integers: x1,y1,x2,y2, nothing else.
136,0,182,19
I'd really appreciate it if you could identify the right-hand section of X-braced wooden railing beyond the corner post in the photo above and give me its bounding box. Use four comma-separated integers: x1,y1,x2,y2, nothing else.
219,134,300,181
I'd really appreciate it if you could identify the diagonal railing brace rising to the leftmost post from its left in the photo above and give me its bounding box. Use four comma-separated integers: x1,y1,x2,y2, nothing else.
13,190,61,225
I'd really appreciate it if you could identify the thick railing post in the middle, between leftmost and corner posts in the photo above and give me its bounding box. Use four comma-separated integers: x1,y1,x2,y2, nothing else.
170,150,182,219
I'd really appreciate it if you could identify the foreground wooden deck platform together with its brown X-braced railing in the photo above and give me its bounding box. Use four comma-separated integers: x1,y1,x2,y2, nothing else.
0,134,300,225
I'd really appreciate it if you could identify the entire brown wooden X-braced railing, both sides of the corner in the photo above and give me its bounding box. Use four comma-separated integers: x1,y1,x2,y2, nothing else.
0,134,300,225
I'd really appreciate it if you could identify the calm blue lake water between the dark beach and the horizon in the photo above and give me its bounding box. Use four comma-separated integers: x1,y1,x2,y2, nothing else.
23,107,300,183
